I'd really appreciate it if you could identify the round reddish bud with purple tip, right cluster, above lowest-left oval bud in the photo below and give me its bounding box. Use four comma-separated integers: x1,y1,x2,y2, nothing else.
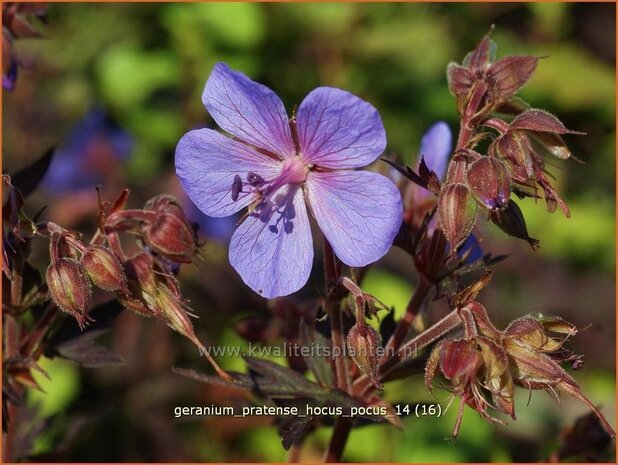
466,157,511,210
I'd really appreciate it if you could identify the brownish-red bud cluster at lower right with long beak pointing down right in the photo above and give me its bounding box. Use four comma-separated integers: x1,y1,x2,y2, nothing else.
425,301,614,436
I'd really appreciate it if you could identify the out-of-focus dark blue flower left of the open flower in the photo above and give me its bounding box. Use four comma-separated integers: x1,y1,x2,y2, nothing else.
42,108,133,195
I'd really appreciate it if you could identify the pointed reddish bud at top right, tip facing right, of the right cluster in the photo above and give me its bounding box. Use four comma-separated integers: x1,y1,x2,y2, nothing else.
487,55,539,99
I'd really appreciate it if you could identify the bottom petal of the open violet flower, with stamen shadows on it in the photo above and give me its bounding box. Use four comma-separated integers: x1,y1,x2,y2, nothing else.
229,185,313,298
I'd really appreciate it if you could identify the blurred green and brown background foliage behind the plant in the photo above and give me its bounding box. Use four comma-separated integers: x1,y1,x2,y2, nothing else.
2,3,616,462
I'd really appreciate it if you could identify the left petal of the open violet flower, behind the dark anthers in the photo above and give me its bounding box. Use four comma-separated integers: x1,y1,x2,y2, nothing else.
176,129,282,217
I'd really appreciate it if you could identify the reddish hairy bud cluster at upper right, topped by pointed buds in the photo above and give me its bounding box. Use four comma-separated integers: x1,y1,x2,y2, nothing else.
437,29,582,253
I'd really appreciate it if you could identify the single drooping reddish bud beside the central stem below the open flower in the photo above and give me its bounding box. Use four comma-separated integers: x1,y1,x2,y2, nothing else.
347,323,382,390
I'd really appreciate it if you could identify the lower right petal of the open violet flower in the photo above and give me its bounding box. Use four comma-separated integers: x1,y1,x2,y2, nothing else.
305,171,402,266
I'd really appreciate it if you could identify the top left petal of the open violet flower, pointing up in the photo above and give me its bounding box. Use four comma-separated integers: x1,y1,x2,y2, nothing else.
202,63,296,158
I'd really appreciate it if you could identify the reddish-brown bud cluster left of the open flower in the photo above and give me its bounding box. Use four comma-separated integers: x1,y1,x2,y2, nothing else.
42,191,202,347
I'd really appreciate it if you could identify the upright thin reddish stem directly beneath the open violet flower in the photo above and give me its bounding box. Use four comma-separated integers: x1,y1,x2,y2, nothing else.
324,238,351,393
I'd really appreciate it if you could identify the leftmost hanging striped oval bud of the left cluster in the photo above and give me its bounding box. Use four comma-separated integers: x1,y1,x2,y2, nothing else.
45,258,91,328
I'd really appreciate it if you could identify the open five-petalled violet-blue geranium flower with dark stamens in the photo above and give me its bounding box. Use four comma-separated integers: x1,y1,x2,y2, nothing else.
176,63,402,298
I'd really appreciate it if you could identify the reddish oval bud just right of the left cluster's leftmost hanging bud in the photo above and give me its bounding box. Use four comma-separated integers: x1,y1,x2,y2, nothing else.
81,245,128,293
